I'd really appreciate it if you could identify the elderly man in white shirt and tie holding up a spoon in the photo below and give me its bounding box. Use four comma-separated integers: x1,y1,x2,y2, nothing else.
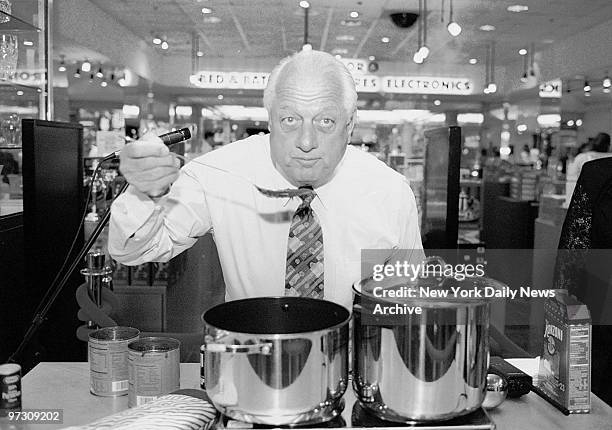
109,50,423,307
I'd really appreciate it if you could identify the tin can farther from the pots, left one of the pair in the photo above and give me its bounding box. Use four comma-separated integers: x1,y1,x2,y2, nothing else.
87,327,140,397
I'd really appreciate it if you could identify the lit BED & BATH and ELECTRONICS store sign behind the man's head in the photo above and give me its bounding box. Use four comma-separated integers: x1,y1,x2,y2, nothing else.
189,70,474,95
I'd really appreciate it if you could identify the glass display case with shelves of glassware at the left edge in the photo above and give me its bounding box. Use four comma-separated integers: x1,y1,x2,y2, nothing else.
0,0,52,217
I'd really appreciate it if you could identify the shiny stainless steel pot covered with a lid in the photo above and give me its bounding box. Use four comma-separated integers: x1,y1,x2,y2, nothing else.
353,278,502,422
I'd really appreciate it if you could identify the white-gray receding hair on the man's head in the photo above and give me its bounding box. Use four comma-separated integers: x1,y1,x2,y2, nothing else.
263,49,357,116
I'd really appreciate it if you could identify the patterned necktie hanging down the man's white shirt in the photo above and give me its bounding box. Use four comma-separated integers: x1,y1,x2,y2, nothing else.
285,188,323,299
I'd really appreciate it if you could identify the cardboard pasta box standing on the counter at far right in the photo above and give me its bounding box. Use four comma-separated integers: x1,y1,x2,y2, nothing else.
537,290,591,414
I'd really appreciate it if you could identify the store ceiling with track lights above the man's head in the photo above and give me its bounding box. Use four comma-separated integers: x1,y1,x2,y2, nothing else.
85,0,612,67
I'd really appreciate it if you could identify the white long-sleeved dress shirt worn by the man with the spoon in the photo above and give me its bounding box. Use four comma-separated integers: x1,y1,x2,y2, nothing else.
109,135,423,309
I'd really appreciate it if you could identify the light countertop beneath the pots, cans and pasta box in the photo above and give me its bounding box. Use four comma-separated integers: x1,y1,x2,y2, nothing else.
0,359,612,430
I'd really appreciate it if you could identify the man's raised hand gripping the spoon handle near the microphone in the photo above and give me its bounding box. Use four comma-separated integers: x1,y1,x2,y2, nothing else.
119,133,180,197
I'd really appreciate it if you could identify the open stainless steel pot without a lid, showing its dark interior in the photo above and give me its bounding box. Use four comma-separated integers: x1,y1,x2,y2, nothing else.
203,297,350,425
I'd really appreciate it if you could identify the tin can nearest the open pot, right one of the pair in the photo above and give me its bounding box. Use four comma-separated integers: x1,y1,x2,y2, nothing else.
128,337,181,408
